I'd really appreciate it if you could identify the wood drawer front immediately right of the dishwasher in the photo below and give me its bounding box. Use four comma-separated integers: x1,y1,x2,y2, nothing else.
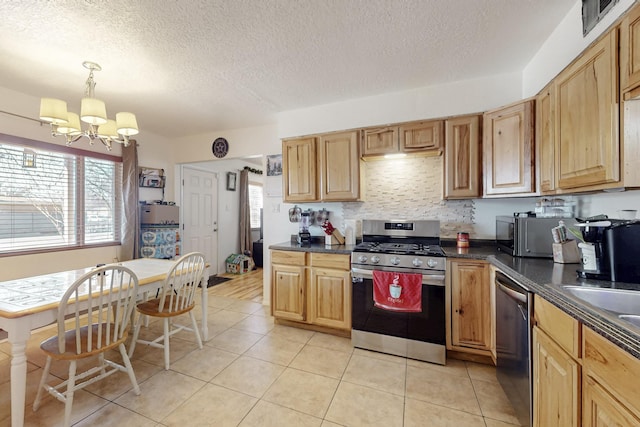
533,295,581,359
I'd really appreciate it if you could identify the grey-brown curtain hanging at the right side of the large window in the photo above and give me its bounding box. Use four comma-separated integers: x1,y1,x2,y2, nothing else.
120,140,140,261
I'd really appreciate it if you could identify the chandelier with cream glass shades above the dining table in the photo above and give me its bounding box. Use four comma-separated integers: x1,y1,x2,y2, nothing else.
40,61,138,151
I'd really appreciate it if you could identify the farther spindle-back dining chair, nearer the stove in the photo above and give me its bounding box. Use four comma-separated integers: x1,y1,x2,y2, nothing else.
129,252,202,370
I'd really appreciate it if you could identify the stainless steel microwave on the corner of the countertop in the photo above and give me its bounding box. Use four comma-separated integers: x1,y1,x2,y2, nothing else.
496,216,575,258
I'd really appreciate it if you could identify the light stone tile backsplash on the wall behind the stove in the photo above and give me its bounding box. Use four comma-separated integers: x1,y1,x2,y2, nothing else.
343,156,474,238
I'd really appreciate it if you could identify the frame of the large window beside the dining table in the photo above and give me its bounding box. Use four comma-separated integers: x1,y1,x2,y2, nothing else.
0,133,123,258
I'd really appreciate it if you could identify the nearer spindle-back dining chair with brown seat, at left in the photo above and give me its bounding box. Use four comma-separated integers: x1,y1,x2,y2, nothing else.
33,265,140,427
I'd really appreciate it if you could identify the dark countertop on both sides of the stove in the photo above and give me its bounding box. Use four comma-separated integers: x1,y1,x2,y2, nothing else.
269,239,640,359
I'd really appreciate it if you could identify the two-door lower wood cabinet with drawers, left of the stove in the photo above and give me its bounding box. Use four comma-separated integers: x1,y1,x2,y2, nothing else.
271,250,351,335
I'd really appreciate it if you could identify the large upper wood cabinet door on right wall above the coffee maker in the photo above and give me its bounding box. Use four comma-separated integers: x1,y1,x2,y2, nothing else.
555,29,620,189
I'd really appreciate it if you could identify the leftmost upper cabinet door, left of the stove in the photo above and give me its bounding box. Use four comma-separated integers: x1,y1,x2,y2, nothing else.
282,137,319,202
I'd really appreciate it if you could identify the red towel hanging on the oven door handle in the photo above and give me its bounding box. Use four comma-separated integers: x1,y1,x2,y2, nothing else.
373,270,422,313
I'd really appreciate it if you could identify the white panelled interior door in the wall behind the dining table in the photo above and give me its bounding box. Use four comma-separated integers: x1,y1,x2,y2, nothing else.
182,166,218,274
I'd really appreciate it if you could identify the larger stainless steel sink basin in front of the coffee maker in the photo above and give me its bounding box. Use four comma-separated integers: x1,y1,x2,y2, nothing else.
563,286,640,314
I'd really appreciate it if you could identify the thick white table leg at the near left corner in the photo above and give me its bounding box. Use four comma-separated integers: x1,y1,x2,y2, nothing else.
8,325,31,427
